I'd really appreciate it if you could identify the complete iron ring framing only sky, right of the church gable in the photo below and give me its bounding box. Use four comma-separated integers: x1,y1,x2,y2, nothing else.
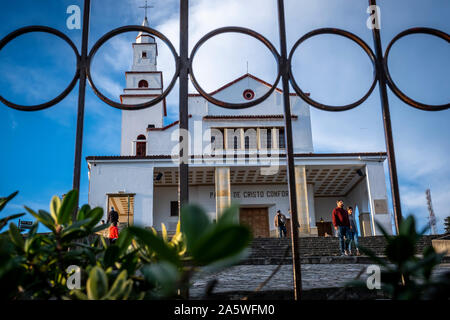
288,28,377,111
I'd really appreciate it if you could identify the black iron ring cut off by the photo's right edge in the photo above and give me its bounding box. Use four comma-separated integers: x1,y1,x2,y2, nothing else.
383,28,450,111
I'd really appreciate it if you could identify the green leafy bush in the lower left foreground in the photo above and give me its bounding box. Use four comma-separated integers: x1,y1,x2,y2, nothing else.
0,190,251,300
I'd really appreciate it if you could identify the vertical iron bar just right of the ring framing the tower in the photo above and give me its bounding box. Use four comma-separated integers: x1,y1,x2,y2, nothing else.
178,0,189,209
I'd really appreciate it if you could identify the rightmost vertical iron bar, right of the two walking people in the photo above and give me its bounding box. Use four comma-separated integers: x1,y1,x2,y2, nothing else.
369,0,402,234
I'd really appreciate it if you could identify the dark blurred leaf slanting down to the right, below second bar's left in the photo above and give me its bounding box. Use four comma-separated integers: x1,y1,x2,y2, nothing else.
128,226,180,265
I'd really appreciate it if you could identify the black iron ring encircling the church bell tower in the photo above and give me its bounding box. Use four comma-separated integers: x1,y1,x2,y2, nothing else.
86,26,180,110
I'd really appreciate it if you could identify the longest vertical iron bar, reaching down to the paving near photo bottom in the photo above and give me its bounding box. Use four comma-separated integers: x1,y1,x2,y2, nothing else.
278,0,302,300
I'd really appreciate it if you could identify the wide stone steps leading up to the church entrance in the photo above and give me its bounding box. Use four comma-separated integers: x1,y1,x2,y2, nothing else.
241,235,448,265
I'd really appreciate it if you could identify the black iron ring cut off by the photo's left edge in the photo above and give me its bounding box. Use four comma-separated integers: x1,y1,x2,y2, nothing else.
0,26,80,111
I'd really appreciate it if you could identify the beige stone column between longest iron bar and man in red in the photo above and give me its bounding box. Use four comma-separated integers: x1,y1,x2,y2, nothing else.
295,165,311,235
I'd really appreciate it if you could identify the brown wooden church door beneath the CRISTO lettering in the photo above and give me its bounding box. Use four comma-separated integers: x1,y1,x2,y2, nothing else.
239,208,270,238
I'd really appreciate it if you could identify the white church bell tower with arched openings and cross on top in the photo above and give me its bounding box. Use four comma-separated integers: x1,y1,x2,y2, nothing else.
120,14,166,156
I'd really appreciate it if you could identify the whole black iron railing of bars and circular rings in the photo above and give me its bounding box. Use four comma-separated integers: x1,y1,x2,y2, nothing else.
0,0,450,299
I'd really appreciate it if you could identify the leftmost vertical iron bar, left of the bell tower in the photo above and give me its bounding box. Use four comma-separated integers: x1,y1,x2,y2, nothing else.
72,0,91,221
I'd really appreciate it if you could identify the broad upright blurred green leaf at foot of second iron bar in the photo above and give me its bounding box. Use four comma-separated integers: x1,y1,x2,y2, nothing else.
181,205,211,251
